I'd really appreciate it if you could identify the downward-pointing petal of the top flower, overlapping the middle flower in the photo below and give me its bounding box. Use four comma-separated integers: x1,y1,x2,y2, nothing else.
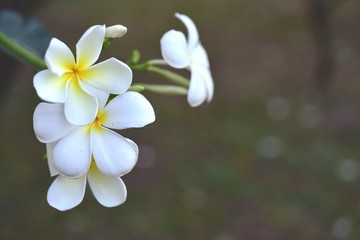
65,79,98,125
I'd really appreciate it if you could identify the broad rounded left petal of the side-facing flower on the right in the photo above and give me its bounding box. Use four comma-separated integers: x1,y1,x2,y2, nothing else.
160,30,190,68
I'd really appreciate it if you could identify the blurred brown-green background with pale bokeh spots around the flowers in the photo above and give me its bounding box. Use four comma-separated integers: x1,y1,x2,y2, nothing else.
0,0,360,240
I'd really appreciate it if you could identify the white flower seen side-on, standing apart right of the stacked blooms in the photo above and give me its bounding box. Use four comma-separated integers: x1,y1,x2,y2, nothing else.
160,13,214,107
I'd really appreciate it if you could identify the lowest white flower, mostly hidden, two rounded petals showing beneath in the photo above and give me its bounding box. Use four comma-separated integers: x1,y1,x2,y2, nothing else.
47,158,127,211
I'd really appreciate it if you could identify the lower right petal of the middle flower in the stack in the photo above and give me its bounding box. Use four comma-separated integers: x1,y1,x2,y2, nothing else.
92,127,139,177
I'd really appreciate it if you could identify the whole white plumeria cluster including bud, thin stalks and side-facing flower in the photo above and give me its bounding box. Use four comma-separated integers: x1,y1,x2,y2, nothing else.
33,13,214,211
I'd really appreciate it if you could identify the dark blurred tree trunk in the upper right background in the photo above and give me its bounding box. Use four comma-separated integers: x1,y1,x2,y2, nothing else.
306,0,336,91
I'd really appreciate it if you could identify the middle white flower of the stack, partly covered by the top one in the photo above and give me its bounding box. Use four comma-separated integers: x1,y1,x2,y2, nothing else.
34,86,155,178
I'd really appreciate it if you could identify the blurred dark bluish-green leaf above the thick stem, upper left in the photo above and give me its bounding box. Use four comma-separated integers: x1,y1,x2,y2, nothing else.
0,9,53,58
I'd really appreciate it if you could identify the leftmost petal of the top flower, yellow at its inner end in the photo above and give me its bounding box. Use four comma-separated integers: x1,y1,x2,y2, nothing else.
34,70,68,103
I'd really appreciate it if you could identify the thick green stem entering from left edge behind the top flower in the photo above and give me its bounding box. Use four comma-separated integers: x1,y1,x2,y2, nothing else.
0,32,47,70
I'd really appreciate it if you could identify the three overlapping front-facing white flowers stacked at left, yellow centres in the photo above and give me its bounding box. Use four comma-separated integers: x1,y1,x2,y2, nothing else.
33,26,155,210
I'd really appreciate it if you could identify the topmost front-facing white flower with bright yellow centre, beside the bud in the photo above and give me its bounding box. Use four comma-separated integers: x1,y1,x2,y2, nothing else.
34,25,132,125
